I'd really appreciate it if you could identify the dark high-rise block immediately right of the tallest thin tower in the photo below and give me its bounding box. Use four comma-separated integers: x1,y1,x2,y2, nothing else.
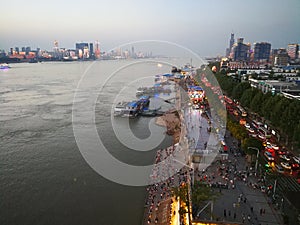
230,38,251,61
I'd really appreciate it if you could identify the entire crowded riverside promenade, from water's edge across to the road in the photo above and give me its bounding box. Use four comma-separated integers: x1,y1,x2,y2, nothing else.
143,76,283,225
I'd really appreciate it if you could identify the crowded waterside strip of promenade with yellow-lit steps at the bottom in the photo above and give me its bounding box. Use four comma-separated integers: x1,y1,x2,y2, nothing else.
143,81,213,225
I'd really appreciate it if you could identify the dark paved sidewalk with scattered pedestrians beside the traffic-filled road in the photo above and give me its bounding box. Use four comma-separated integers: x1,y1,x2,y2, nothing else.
195,130,283,225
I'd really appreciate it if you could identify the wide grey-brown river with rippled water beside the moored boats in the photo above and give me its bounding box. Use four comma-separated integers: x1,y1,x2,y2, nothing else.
0,60,182,225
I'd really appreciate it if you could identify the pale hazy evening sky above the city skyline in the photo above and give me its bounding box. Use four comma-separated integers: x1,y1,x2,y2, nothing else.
0,0,300,56
